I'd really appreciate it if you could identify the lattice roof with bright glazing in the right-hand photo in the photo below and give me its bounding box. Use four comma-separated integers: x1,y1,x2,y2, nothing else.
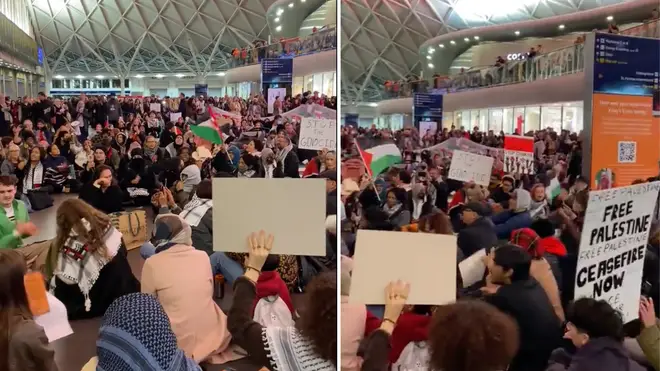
341,0,627,102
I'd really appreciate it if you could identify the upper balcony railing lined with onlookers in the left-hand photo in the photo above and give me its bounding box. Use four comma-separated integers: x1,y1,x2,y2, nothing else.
231,26,337,67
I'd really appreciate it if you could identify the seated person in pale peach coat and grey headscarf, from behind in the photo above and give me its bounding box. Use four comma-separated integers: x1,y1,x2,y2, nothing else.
141,214,231,363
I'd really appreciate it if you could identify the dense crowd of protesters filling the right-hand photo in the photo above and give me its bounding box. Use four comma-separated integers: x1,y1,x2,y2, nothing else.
340,126,660,371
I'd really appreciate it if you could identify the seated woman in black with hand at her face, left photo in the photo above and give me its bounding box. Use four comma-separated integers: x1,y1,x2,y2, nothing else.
80,165,124,214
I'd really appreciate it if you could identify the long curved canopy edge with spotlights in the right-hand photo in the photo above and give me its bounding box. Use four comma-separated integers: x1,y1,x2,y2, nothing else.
420,0,658,75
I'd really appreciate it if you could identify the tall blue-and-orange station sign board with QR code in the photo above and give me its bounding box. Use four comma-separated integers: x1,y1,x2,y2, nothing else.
589,33,660,189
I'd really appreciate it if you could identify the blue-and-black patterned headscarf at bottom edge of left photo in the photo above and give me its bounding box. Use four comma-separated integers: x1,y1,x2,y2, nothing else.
96,293,201,371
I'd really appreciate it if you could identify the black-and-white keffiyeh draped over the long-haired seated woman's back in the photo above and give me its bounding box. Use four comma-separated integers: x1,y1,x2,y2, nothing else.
50,219,122,312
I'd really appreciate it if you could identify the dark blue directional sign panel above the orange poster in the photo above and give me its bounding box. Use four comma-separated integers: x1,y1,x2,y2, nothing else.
594,33,660,96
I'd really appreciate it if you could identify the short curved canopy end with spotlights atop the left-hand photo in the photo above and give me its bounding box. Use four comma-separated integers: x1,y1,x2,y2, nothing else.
262,0,328,39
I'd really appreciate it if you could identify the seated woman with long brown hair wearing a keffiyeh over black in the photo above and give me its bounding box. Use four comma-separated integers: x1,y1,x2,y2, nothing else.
45,199,140,320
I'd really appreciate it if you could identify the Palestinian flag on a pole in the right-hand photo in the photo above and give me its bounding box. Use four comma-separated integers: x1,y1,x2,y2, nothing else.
356,138,402,177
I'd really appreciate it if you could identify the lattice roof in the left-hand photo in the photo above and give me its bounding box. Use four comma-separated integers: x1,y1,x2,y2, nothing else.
27,0,275,76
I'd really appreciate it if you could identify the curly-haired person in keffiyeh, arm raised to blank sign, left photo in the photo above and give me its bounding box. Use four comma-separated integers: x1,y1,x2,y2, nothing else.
227,231,337,371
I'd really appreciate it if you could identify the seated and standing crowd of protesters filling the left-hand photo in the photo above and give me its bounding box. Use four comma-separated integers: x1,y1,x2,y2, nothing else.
0,92,337,371
